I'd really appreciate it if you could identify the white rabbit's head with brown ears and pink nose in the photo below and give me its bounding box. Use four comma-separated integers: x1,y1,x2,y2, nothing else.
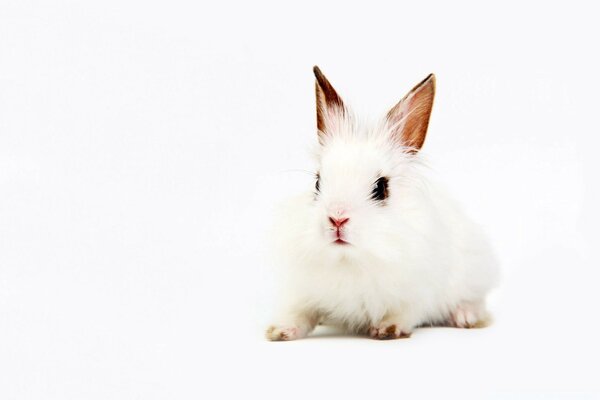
311,67,435,251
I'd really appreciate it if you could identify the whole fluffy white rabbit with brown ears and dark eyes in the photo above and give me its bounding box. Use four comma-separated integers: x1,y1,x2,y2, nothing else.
266,66,499,341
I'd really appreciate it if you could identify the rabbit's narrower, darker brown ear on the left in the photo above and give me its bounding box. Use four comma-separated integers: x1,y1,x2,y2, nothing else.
313,65,345,144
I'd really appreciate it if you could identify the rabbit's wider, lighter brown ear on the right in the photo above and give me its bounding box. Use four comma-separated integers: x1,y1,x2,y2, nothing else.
387,74,435,152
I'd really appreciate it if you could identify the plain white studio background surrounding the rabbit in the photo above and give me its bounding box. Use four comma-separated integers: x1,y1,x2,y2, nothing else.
0,0,600,400
